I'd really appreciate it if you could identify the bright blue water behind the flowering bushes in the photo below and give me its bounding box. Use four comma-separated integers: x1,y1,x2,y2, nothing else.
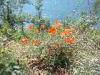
23,0,91,21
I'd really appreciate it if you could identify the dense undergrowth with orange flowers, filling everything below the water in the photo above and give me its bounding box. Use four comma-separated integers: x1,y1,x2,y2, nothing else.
0,16,100,75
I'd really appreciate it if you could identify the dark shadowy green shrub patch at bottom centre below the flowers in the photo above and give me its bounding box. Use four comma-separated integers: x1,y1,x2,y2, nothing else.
43,47,73,72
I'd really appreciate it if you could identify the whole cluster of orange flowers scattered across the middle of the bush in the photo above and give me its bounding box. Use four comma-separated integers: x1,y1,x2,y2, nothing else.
21,20,75,46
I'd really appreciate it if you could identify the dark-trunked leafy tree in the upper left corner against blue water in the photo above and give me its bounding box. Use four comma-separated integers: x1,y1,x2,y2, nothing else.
0,0,28,29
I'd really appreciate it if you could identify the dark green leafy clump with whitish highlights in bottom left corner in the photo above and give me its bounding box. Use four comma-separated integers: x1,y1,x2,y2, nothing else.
0,62,21,75
